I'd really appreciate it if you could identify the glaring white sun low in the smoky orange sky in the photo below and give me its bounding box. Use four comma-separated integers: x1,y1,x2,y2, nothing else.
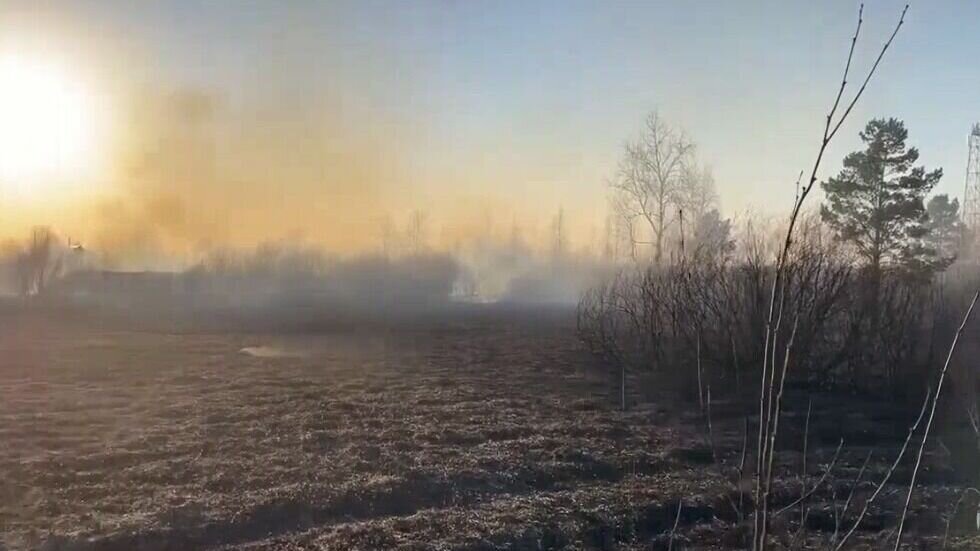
0,53,100,197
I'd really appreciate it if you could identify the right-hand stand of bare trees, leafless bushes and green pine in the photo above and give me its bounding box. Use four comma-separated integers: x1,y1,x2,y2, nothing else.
578,116,978,399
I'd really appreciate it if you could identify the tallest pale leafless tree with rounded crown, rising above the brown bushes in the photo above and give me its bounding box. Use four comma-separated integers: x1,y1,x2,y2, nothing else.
611,112,694,263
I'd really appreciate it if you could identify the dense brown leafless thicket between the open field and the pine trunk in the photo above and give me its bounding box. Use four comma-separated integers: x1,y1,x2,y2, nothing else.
578,216,872,398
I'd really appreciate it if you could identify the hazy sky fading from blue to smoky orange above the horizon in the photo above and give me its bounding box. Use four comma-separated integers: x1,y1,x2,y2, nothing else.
0,0,980,260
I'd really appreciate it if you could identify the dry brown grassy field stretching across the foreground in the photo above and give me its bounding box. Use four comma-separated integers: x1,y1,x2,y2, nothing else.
0,312,973,550
